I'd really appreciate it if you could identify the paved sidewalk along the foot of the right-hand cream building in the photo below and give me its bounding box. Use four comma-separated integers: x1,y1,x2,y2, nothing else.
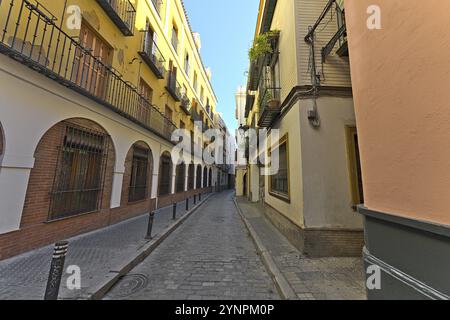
237,198,366,300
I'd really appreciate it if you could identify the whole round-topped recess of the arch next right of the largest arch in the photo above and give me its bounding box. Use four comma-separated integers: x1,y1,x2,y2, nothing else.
128,143,152,202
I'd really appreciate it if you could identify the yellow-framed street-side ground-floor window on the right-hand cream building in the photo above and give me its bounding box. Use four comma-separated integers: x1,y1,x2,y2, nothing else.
269,136,290,200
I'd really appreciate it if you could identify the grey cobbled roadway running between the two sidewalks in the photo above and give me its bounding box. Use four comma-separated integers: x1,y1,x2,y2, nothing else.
106,192,279,300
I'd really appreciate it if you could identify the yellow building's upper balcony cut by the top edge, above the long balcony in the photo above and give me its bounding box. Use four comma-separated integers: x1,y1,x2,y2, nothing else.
97,0,136,37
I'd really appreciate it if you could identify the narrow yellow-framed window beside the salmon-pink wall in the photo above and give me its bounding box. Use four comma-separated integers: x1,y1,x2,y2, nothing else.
346,127,364,211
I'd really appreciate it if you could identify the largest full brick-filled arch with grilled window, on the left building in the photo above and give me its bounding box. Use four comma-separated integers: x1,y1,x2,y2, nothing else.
21,118,115,227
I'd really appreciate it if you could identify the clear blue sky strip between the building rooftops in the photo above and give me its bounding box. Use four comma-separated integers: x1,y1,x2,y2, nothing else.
184,0,259,134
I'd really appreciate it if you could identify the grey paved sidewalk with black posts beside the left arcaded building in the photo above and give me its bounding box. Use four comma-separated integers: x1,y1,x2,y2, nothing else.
0,194,210,300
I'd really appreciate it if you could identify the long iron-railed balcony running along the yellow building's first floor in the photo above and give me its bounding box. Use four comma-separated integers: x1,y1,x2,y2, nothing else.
0,0,176,141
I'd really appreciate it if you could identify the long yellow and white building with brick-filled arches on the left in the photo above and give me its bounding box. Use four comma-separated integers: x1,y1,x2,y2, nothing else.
0,0,218,259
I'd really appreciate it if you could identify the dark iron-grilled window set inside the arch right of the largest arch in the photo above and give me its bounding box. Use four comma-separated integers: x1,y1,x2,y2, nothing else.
128,146,149,202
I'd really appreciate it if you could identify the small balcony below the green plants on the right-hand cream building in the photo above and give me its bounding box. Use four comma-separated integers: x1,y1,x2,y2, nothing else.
258,88,281,128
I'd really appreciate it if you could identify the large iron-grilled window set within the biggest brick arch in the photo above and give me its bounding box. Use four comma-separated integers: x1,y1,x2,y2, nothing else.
49,124,109,220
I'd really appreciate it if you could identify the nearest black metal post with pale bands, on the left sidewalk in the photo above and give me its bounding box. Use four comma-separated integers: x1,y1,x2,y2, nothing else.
44,241,69,300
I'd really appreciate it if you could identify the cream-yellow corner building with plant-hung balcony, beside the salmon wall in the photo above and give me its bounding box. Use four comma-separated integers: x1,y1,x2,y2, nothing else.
241,0,363,256
